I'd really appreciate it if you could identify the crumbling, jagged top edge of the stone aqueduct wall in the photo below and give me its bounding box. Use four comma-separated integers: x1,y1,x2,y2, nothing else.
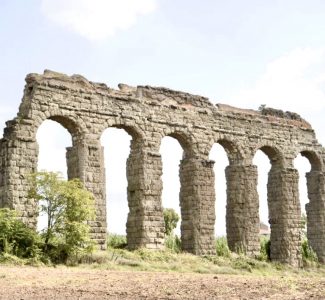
26,70,312,129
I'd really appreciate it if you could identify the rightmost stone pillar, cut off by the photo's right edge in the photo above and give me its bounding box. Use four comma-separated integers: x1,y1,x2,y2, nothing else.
306,171,325,263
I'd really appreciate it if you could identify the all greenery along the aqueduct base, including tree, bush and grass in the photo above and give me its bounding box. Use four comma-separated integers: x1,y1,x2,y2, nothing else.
0,172,325,275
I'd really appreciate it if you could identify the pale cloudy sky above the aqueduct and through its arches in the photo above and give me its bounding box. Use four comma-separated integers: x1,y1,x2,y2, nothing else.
0,0,325,234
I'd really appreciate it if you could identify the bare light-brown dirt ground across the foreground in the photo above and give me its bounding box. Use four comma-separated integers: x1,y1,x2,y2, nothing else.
0,265,325,300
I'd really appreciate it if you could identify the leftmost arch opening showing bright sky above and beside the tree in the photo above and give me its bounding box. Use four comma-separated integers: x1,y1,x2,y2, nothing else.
36,120,72,231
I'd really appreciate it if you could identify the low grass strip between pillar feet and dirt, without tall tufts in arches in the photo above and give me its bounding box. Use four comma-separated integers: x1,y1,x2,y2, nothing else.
81,248,325,276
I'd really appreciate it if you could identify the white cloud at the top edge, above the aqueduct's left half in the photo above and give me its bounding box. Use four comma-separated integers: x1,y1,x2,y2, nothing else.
41,0,157,40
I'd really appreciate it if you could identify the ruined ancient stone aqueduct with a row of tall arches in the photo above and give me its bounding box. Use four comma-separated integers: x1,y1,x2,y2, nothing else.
0,71,325,265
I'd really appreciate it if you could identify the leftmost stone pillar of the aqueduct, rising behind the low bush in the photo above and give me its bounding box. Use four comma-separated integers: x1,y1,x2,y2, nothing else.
0,119,38,228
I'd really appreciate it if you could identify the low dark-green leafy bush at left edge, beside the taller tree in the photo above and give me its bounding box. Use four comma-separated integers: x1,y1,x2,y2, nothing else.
0,208,41,258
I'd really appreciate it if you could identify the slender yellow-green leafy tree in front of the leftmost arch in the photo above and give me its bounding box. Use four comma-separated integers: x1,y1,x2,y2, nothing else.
29,172,94,261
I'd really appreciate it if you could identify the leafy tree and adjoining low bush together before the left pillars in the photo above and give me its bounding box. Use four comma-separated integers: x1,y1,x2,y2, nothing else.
0,172,95,265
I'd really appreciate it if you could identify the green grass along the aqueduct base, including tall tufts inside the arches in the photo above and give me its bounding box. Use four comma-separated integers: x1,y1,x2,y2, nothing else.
0,235,325,276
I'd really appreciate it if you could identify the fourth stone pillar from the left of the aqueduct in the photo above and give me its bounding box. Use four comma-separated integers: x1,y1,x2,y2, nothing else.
180,158,215,255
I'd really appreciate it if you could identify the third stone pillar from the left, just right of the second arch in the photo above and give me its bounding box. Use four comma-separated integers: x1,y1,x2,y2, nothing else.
126,145,165,249
